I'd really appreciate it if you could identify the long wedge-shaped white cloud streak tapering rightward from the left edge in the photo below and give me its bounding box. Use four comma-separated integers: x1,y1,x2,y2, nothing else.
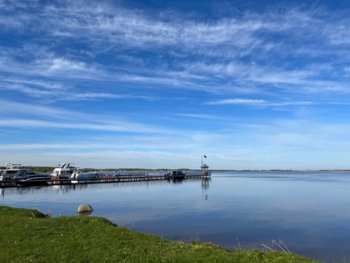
0,100,169,134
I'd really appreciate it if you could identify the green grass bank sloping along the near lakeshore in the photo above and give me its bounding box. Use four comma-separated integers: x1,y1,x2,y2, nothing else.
0,206,316,263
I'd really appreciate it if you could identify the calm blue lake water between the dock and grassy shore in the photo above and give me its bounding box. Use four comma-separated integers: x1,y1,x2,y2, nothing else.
0,172,350,262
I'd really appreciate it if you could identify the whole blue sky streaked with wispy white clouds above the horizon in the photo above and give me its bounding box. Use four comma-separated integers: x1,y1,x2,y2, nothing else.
0,0,350,169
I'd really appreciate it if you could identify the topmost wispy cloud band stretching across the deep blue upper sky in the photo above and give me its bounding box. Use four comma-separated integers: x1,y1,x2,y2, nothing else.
2,1,344,56
